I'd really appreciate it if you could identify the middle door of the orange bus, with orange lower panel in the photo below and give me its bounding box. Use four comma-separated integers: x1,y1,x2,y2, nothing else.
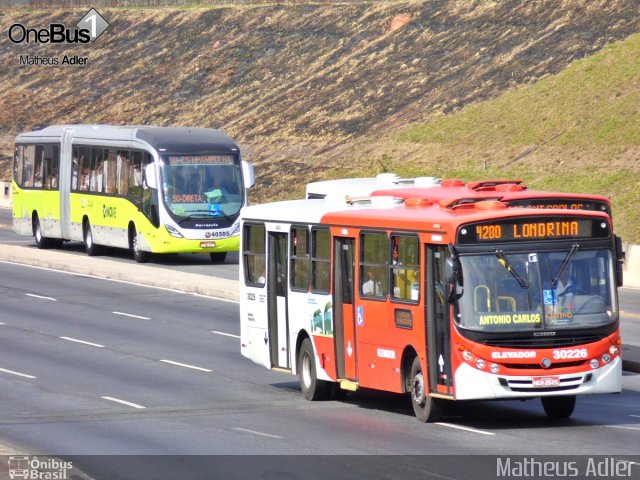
332,237,357,380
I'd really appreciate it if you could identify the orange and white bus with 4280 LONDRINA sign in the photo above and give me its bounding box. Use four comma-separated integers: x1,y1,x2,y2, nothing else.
240,196,622,421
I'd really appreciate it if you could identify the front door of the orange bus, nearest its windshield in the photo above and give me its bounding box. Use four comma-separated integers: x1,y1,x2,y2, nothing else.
425,245,453,396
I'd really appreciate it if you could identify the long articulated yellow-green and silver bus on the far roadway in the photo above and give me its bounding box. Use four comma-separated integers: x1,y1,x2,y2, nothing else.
13,125,255,262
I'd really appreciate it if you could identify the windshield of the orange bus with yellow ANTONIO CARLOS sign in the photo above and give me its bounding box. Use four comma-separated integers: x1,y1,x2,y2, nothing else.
457,248,617,332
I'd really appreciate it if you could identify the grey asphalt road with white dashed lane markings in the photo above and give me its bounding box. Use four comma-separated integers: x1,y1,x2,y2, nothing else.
0,210,640,479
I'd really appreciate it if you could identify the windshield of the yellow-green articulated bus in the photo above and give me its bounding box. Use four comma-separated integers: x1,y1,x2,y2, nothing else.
161,154,244,226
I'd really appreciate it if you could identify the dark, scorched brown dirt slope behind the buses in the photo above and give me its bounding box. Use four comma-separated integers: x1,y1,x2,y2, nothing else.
0,0,640,200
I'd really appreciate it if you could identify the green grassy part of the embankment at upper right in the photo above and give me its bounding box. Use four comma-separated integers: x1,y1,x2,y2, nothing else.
350,35,640,243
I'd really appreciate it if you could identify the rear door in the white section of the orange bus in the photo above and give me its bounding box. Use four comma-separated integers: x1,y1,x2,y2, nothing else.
267,232,291,369
